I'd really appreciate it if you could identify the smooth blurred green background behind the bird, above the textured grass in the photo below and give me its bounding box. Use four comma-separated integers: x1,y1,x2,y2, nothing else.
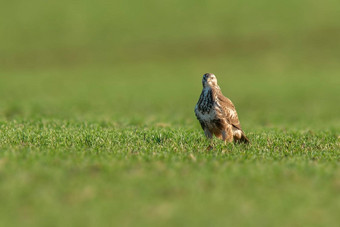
0,0,340,128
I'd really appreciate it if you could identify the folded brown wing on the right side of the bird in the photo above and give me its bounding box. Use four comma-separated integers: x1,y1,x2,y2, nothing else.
217,93,242,130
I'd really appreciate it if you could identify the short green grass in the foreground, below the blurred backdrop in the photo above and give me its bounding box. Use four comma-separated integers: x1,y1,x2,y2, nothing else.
0,120,340,226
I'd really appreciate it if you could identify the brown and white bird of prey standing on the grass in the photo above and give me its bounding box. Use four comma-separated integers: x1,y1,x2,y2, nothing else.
195,73,250,144
